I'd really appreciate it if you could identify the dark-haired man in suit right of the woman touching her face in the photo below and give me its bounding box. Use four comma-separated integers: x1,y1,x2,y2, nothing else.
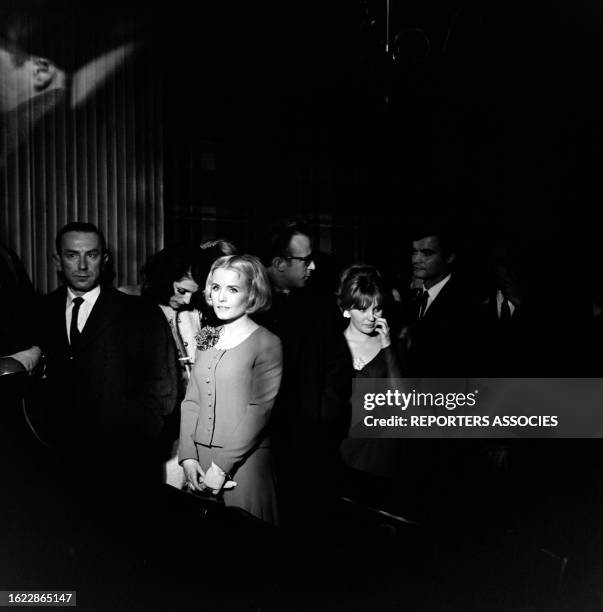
405,222,482,520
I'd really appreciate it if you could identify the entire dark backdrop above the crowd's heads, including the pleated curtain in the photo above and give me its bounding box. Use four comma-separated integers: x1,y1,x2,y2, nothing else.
0,0,603,290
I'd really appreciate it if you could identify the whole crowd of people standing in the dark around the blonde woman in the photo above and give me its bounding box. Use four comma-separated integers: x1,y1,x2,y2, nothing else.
2,221,596,525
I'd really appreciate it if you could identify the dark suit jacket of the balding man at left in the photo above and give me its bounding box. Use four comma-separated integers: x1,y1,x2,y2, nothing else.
34,287,178,460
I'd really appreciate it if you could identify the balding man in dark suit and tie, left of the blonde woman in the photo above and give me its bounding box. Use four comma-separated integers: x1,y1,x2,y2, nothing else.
39,222,177,480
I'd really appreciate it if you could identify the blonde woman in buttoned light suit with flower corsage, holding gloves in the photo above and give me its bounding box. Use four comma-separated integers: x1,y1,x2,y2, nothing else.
179,255,282,524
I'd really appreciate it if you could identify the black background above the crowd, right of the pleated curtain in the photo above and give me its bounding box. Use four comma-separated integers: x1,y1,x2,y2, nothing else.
161,1,600,268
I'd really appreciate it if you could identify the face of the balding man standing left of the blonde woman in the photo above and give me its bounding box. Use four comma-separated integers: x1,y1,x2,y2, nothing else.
55,232,107,295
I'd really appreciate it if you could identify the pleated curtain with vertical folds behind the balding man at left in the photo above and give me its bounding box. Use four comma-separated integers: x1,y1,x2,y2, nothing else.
0,5,164,293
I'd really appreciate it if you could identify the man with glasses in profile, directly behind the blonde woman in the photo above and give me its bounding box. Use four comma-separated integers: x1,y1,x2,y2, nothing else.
258,221,335,525
